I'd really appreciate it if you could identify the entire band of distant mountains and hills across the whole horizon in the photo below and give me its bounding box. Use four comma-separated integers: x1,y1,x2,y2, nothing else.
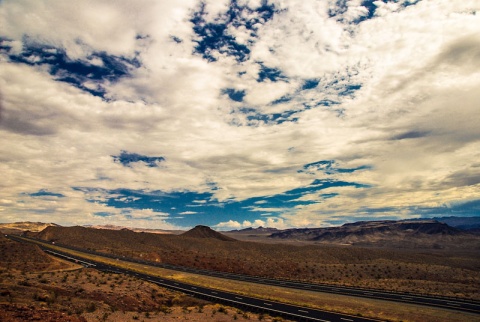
0,217,480,249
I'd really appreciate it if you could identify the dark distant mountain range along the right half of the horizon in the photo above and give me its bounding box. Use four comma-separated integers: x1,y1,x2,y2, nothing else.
224,217,480,248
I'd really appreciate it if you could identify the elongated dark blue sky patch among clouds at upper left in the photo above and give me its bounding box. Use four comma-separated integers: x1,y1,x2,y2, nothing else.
0,38,140,98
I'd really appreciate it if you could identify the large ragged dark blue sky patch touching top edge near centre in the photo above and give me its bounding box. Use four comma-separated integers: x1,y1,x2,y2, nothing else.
190,0,275,62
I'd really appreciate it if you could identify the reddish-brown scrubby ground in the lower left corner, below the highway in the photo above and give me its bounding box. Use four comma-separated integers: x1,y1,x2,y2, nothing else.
0,236,284,322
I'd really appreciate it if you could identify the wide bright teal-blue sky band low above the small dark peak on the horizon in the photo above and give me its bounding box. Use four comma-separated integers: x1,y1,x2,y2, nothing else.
77,180,368,227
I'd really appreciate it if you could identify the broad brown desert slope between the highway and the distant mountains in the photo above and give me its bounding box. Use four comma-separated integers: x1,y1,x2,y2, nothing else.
31,227,480,299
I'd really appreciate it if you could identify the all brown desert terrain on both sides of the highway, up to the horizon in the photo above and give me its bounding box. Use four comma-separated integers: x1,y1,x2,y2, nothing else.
0,221,480,321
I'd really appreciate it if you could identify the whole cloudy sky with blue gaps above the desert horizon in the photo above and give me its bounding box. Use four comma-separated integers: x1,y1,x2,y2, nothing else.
0,0,480,230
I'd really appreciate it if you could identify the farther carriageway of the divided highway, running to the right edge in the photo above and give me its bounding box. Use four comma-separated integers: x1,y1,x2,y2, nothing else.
7,235,480,314
